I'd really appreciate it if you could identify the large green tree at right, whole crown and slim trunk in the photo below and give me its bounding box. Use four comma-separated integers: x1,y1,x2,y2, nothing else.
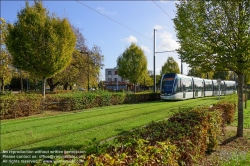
174,0,250,137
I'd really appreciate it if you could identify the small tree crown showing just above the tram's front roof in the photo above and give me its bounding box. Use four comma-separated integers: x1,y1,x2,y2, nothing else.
160,56,180,76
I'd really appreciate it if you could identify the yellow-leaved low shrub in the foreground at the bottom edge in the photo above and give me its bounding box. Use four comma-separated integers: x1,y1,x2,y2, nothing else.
88,139,179,166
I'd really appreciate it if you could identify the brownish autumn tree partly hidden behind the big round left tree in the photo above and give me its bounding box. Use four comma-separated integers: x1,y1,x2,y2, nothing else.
47,25,103,91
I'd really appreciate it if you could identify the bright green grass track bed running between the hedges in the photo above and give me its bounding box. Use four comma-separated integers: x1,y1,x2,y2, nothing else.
1,97,221,151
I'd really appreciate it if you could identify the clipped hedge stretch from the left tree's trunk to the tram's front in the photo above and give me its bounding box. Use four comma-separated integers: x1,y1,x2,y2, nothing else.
46,91,160,111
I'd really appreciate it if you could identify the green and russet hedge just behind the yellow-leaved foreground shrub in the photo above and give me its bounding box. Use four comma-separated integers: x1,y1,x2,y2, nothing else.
117,107,222,165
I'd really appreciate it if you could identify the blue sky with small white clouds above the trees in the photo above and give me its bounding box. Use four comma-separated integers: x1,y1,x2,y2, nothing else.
0,0,188,80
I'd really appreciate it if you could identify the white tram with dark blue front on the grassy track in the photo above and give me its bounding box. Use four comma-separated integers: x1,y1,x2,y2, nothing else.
160,73,236,100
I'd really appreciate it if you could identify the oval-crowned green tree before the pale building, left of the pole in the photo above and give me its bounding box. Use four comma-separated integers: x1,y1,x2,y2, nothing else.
117,43,147,93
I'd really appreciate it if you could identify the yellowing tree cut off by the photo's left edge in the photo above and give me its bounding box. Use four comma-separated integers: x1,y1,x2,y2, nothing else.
0,18,12,93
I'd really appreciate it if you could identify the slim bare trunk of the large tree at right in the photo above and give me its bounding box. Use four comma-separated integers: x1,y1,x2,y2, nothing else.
237,73,244,137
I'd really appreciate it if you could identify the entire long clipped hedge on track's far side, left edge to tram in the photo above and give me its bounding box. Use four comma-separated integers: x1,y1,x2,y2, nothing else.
0,91,160,119
